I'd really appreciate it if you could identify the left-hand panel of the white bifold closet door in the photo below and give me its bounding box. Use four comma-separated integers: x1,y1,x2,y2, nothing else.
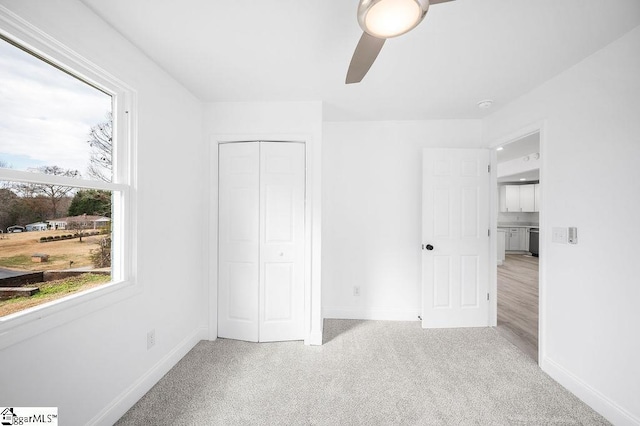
218,142,260,342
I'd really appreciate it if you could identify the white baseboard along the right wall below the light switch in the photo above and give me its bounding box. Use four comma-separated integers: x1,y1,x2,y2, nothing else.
540,357,640,426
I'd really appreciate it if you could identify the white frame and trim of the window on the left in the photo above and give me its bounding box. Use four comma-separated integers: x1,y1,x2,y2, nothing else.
0,5,142,350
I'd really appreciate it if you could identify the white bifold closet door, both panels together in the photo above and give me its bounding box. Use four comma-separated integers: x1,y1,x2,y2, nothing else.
218,142,305,342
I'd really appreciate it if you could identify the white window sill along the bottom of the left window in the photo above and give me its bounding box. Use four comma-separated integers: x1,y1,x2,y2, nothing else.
0,281,142,350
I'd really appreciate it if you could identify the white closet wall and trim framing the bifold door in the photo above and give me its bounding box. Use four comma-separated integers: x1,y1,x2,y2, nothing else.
204,102,322,345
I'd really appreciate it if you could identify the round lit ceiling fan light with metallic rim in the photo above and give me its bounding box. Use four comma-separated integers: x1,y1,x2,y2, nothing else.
358,0,429,38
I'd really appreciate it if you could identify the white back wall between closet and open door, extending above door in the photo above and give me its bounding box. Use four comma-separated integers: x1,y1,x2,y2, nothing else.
322,120,482,320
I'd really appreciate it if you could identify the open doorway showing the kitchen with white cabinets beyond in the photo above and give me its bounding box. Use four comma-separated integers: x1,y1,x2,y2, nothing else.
496,131,542,362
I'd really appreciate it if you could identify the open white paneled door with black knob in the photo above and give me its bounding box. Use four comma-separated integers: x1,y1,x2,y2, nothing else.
422,149,490,328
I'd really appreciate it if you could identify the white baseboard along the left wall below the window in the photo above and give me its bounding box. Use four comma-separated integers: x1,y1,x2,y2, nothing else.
87,328,207,426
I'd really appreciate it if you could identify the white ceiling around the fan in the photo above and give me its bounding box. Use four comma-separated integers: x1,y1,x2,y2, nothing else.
82,0,640,121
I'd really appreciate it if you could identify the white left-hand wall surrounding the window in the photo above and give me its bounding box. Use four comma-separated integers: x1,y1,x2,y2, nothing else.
0,0,206,425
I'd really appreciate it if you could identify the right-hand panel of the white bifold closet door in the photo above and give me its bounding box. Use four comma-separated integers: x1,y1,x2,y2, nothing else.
260,142,305,342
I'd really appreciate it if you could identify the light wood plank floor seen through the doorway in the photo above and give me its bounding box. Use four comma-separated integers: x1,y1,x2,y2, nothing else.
498,254,538,361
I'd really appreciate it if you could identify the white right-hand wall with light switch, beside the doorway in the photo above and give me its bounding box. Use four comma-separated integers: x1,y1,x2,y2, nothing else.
483,27,640,425
